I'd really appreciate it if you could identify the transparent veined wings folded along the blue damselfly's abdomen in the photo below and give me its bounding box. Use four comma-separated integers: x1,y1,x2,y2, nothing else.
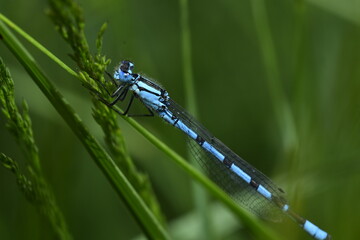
168,99,285,221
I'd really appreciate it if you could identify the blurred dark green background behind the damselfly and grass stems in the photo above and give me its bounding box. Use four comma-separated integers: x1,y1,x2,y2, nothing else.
0,0,360,239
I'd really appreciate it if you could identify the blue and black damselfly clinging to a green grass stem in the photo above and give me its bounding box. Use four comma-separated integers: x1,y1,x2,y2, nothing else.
90,60,331,240
